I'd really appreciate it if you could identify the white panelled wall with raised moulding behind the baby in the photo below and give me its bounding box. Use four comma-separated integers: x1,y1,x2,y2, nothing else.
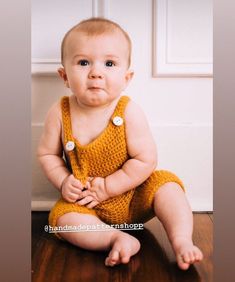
32,0,213,211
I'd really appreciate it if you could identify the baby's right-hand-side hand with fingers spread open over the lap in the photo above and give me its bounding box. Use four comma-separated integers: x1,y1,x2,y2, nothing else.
77,177,110,209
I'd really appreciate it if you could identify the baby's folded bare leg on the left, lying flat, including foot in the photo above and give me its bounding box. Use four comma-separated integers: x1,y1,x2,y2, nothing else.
57,212,140,266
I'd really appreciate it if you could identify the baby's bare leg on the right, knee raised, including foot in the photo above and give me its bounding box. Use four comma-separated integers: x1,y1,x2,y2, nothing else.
154,182,203,270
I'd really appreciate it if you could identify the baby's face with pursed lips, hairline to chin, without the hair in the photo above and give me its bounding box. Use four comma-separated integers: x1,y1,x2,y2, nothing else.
60,31,133,107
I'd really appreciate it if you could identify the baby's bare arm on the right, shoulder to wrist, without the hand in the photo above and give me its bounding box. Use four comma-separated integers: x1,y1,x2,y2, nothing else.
105,101,157,197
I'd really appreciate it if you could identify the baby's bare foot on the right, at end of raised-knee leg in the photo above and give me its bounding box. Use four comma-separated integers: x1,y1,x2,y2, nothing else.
172,237,203,270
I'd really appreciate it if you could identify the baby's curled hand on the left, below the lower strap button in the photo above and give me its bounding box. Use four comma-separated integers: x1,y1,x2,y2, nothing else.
61,174,84,203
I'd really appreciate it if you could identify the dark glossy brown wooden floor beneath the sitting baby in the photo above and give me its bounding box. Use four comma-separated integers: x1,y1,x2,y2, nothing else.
32,212,213,282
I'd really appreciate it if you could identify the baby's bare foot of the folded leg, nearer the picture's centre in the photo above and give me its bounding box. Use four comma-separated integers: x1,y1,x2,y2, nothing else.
105,232,140,266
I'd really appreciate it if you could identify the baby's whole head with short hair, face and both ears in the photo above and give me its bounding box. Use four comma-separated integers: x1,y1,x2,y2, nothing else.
58,18,133,106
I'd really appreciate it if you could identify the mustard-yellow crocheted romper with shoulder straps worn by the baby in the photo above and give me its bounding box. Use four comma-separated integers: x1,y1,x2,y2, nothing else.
49,96,184,237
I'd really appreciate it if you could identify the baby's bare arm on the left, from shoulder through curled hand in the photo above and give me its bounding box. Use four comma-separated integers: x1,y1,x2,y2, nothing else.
37,103,83,202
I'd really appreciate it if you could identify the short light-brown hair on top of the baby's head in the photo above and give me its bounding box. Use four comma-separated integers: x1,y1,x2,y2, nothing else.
61,18,131,67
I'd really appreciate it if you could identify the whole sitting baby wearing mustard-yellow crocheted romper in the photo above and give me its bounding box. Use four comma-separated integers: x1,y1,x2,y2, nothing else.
38,18,203,270
